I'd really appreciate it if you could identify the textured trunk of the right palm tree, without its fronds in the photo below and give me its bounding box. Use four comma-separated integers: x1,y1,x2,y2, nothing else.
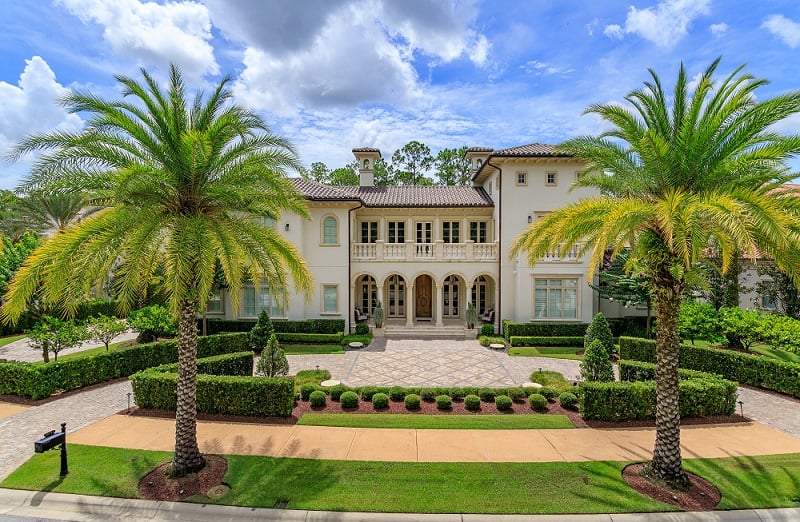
649,267,689,489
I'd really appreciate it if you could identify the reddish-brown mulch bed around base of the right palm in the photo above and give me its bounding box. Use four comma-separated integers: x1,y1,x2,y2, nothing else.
622,463,722,511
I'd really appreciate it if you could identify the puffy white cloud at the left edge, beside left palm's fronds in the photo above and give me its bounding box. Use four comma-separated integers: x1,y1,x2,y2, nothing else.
0,56,83,189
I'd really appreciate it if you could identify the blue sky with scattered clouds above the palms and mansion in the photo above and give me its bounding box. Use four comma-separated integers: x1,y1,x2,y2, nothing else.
0,0,800,188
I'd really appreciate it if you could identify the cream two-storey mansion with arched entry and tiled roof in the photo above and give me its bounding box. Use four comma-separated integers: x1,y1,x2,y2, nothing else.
206,144,618,333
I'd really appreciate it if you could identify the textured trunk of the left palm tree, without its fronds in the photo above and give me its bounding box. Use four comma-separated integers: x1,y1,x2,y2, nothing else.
167,299,205,477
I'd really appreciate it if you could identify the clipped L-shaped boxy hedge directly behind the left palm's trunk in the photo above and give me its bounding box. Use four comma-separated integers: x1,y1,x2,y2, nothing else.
131,352,294,417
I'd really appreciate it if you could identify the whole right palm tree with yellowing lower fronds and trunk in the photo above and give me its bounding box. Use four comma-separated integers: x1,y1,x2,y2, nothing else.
511,59,800,486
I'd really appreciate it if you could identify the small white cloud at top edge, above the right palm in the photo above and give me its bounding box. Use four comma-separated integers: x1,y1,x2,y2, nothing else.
603,0,710,49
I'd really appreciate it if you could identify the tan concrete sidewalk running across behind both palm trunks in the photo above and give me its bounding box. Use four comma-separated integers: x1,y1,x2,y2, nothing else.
69,415,800,462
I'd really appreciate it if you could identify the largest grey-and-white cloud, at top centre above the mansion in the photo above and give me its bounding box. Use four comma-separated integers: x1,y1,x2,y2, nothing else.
206,0,491,115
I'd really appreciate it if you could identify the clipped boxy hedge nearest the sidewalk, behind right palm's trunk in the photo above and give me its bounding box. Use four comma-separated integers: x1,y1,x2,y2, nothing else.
579,377,737,422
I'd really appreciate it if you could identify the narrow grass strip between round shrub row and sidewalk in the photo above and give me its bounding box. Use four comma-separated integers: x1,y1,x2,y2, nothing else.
297,413,575,430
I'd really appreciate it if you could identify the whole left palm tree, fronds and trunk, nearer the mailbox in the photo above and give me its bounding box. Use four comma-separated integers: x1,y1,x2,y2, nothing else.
1,66,311,476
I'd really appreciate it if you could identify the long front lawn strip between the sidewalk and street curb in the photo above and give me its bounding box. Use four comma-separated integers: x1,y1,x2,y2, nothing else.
6,444,800,514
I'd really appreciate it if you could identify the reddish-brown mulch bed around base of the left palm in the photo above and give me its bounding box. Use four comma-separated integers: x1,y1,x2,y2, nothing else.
139,455,229,502
